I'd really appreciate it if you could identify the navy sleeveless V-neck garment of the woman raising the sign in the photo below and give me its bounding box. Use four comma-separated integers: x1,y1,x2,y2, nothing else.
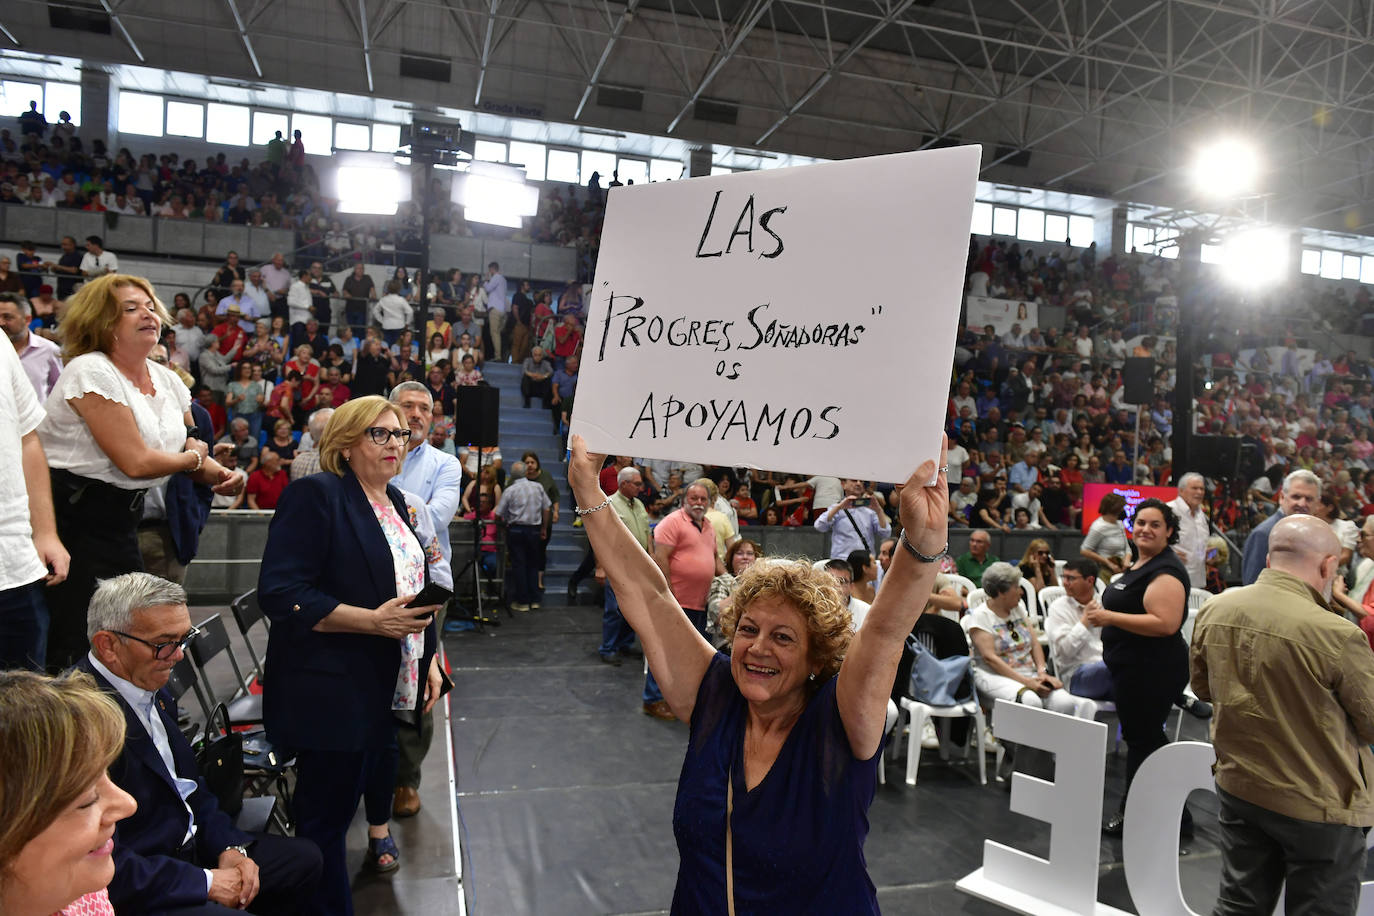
672,654,881,916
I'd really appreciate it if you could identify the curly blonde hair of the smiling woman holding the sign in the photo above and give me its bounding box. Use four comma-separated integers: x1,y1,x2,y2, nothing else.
720,558,853,685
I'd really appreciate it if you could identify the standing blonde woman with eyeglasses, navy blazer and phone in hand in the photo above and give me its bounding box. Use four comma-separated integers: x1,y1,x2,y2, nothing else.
258,396,440,916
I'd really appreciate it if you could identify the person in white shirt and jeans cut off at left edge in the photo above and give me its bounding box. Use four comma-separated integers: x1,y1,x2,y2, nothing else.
0,336,70,672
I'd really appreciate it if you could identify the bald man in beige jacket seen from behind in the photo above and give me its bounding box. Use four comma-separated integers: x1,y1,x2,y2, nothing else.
1191,515,1374,916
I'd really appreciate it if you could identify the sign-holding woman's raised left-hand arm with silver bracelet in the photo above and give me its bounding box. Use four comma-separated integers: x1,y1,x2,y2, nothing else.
567,435,719,725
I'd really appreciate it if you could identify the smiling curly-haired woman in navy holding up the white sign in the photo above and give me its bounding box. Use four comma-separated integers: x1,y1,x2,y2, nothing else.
567,435,949,913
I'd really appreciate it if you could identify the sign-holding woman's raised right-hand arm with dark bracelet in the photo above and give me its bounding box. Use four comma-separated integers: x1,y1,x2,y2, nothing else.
835,438,949,759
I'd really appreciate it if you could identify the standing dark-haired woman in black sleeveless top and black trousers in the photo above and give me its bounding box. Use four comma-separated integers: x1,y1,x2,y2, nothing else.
1085,499,1193,834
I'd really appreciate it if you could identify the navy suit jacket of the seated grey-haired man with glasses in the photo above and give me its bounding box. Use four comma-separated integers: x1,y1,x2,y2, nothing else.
77,655,253,916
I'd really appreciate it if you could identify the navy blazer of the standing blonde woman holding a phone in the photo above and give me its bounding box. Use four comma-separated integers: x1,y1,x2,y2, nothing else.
258,471,436,751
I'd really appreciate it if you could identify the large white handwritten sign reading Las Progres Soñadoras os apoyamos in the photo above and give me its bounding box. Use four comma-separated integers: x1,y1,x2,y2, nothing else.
572,147,980,482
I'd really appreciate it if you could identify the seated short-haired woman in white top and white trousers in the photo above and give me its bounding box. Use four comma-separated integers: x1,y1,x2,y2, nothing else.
969,563,1098,718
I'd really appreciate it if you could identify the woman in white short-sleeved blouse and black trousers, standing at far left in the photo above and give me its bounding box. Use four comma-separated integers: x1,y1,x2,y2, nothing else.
38,273,245,670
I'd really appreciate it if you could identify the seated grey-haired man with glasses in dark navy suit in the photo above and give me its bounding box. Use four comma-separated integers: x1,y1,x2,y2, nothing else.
78,573,320,916
